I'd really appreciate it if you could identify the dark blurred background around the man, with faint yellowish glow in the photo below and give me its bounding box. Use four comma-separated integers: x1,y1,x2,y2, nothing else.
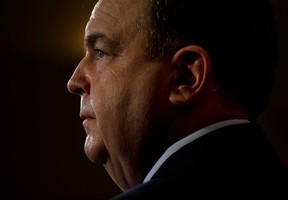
0,0,288,200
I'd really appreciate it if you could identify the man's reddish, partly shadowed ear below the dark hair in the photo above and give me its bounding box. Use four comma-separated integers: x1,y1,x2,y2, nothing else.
169,45,210,105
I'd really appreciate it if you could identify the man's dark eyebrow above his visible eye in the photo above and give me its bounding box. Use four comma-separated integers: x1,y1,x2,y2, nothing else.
84,32,120,52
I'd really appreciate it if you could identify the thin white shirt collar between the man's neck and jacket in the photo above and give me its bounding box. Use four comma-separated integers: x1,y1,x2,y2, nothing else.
143,119,250,183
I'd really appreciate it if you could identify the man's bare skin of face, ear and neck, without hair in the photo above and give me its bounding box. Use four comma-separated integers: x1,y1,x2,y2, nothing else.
67,0,249,190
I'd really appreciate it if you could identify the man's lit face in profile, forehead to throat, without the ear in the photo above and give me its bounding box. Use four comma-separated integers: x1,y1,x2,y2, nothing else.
68,0,176,189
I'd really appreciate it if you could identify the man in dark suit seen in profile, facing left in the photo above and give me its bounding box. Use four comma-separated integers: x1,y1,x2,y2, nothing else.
68,0,288,199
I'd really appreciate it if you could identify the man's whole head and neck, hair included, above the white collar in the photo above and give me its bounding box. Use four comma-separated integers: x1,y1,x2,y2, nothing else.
68,0,275,190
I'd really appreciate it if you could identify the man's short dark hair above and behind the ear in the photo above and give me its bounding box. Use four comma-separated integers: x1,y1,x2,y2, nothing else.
146,0,278,120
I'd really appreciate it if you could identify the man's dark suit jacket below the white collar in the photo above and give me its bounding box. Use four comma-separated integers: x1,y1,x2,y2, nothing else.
114,124,288,200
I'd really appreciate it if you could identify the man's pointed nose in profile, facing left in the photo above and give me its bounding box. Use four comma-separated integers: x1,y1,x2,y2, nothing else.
67,60,90,96
